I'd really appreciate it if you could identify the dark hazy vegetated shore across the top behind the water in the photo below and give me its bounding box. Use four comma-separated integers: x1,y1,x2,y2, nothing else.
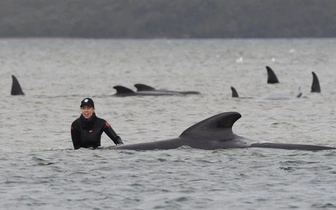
0,0,336,38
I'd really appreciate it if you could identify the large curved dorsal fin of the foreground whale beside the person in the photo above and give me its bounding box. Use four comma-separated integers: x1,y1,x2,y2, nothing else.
180,112,241,138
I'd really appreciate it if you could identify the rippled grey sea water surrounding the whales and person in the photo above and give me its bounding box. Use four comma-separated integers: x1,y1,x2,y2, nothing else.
0,39,336,210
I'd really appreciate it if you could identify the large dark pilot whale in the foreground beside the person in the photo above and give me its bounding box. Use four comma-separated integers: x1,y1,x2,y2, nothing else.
110,112,336,151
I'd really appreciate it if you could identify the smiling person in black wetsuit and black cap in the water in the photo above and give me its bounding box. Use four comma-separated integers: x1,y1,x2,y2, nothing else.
71,98,123,149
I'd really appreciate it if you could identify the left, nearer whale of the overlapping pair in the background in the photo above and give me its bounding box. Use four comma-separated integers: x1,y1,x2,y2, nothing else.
113,85,182,97
